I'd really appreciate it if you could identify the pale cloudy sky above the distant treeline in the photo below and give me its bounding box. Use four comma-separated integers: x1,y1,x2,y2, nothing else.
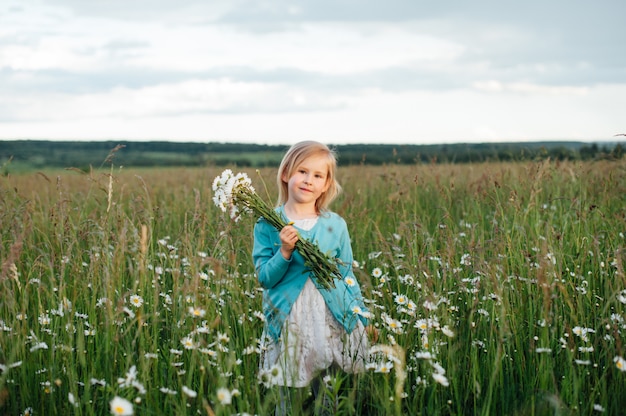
0,0,626,144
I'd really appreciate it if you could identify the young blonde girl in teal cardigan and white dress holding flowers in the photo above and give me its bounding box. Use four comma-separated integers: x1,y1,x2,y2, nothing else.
253,141,369,414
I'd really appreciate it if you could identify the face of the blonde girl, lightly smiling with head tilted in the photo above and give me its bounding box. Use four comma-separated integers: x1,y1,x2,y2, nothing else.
282,155,329,205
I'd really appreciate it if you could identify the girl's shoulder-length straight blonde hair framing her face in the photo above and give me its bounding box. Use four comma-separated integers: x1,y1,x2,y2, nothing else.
276,140,341,214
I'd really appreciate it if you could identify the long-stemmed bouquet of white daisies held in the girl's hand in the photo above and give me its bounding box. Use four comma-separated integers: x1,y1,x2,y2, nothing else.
213,169,341,289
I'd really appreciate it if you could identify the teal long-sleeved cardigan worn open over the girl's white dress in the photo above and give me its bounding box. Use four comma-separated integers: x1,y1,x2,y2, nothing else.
252,206,368,340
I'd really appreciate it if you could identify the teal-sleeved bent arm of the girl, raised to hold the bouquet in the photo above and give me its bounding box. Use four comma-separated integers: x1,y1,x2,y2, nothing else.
252,218,291,289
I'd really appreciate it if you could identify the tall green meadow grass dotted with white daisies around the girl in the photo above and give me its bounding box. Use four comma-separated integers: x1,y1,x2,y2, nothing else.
0,160,626,415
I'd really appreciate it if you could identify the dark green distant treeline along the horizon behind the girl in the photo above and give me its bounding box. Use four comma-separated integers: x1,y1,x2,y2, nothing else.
0,140,624,173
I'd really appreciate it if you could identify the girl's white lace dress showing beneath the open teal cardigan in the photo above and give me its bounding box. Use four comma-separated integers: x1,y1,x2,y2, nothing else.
261,218,369,387
